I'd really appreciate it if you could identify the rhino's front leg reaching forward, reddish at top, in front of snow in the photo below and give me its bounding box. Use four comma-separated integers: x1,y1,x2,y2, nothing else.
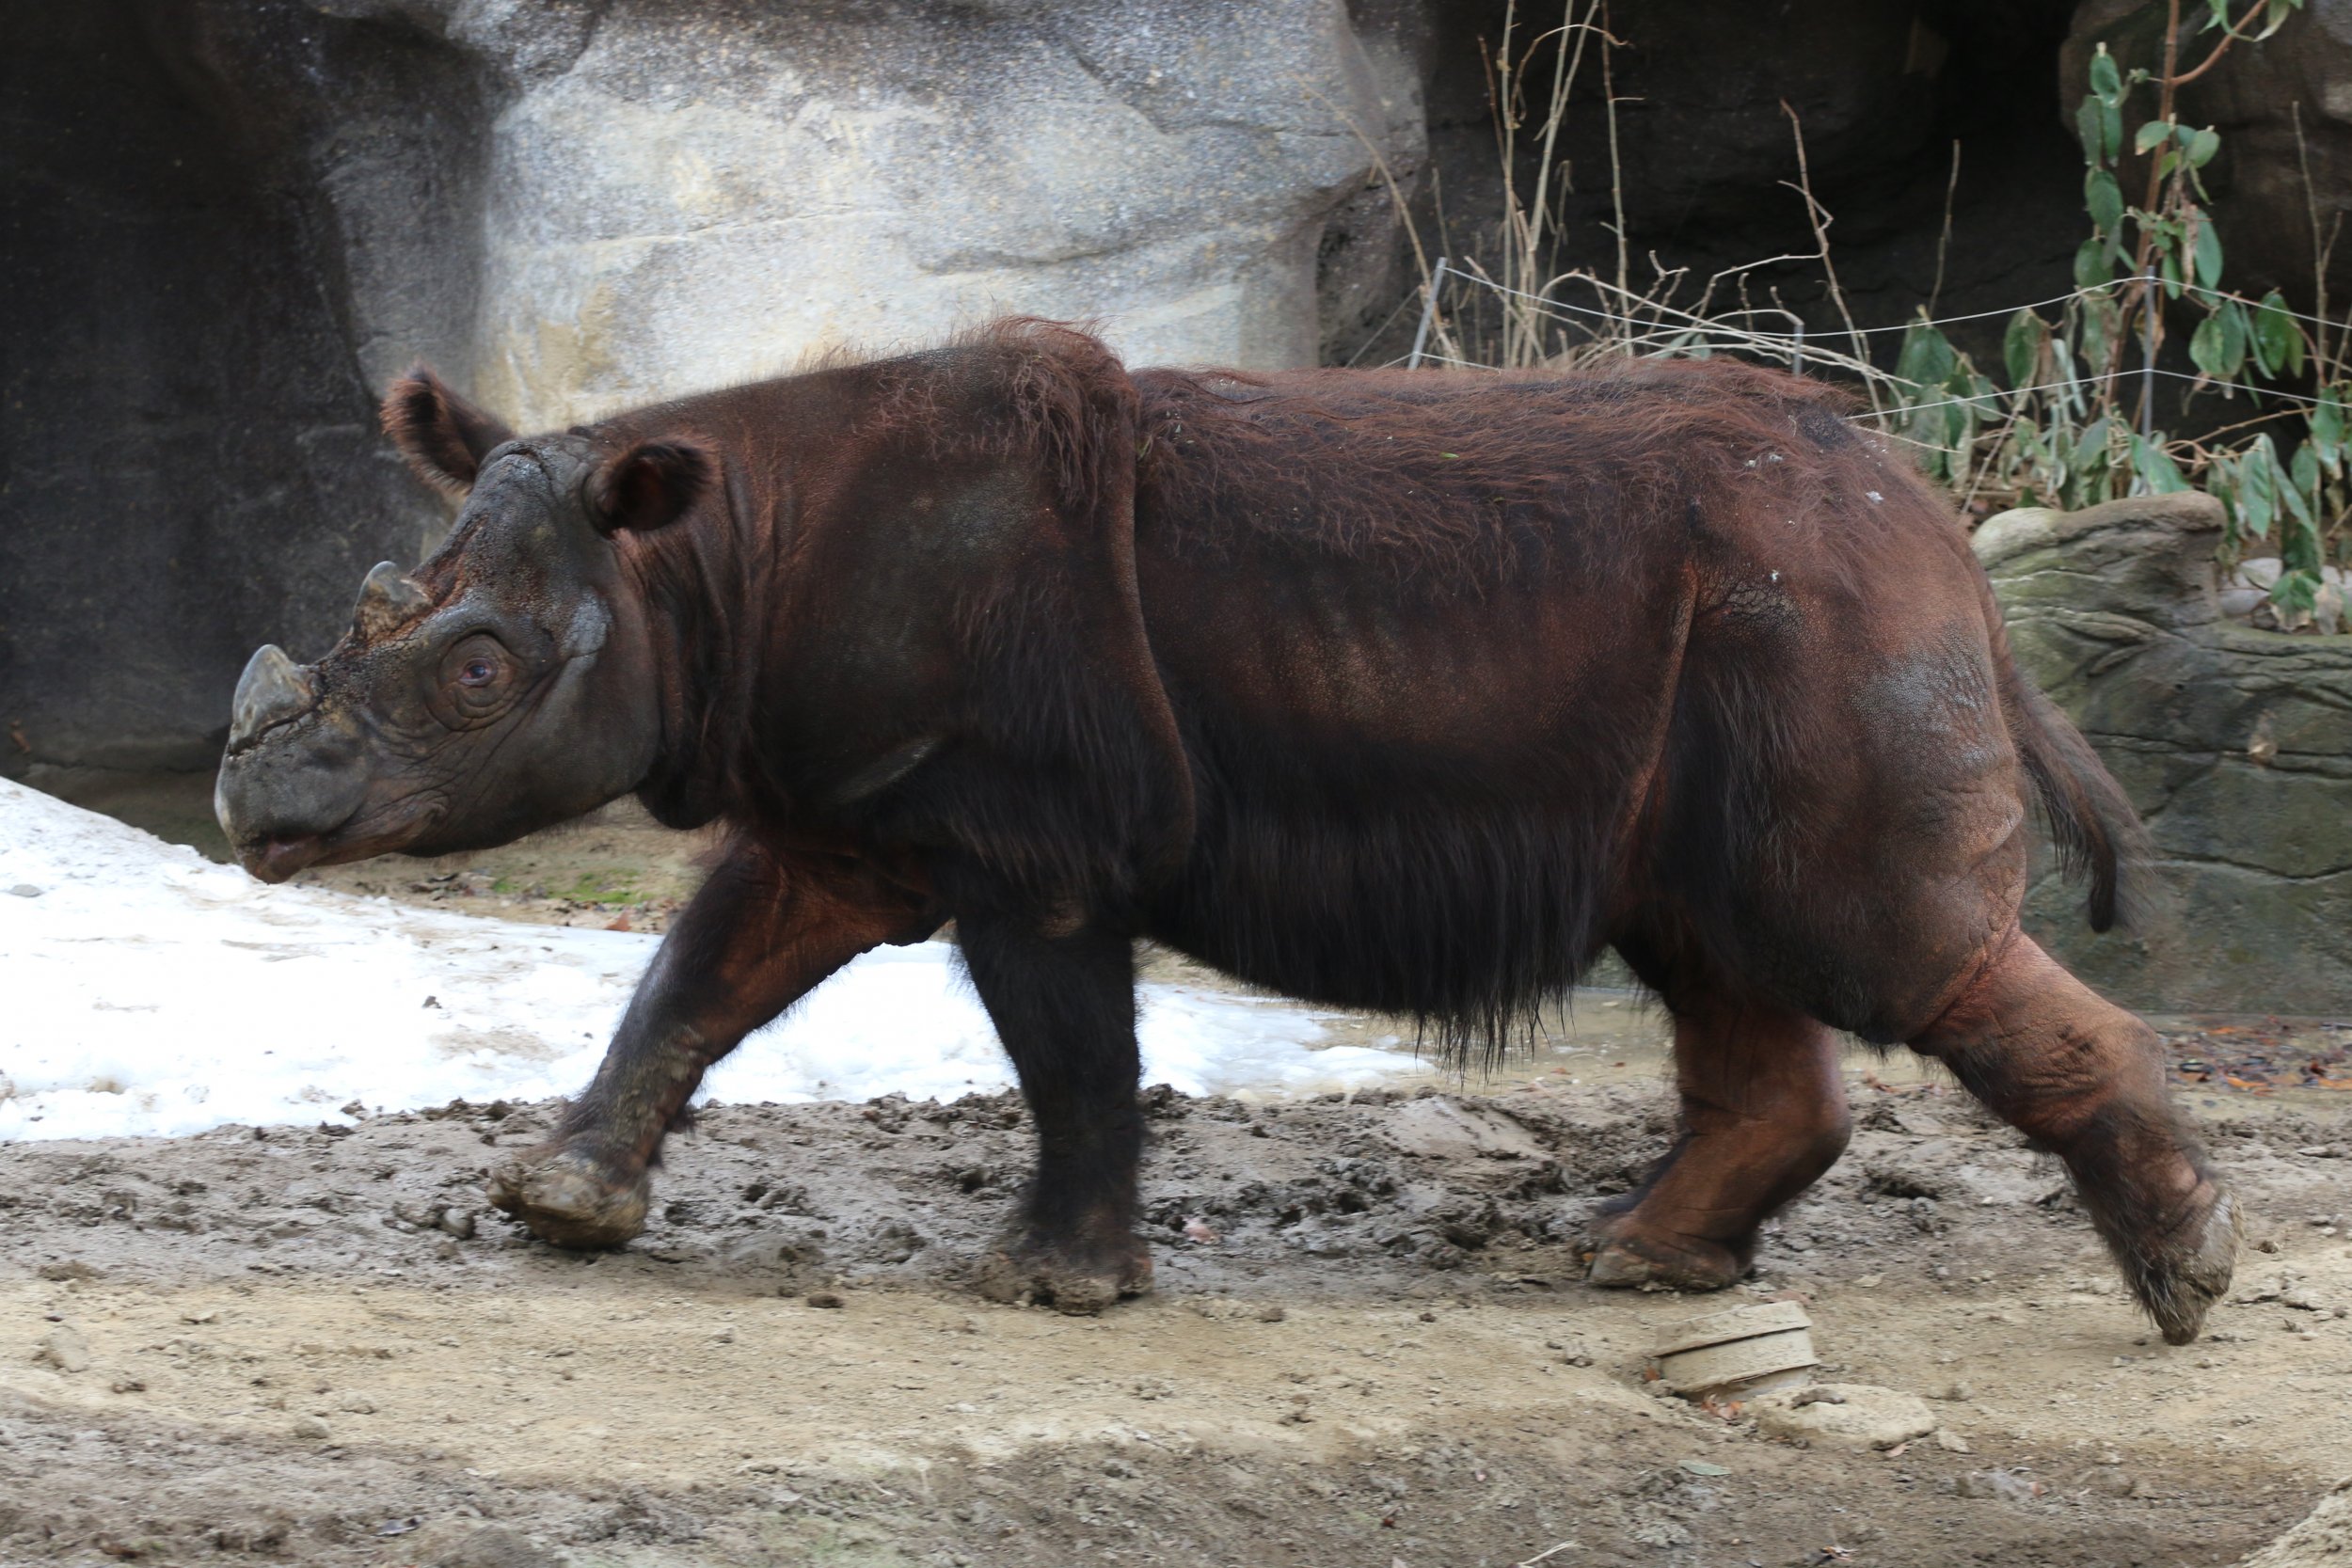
489,842,930,1248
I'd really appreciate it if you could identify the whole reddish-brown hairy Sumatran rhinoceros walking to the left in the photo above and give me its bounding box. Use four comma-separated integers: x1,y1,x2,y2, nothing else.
219,322,2237,1342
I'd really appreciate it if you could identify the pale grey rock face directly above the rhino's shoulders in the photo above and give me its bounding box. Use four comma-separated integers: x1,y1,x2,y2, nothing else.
452,0,1421,425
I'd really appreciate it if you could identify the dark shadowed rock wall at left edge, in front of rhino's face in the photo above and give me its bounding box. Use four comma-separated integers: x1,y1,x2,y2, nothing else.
0,0,456,773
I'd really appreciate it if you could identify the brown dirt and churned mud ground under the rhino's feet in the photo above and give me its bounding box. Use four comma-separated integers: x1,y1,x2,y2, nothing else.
13,784,2352,1568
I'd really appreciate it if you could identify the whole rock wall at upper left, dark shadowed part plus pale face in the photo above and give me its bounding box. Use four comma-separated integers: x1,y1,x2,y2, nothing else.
0,0,1423,783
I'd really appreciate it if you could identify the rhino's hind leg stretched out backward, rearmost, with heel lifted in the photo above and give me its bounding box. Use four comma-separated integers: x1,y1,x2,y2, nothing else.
1910,928,2239,1345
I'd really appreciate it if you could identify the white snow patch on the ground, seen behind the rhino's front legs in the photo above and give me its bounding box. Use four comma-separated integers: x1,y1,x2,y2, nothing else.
0,781,1419,1140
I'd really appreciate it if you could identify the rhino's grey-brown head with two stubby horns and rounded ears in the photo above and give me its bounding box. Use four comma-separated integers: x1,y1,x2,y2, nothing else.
215,367,715,881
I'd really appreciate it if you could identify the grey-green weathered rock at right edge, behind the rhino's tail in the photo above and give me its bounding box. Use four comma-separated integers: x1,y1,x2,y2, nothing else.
1976,494,2352,1013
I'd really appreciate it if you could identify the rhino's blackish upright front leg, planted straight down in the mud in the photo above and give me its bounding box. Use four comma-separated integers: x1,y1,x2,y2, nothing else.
958,917,1152,1314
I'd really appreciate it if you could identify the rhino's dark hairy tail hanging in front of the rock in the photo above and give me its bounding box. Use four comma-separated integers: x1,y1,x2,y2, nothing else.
1985,583,2148,931
